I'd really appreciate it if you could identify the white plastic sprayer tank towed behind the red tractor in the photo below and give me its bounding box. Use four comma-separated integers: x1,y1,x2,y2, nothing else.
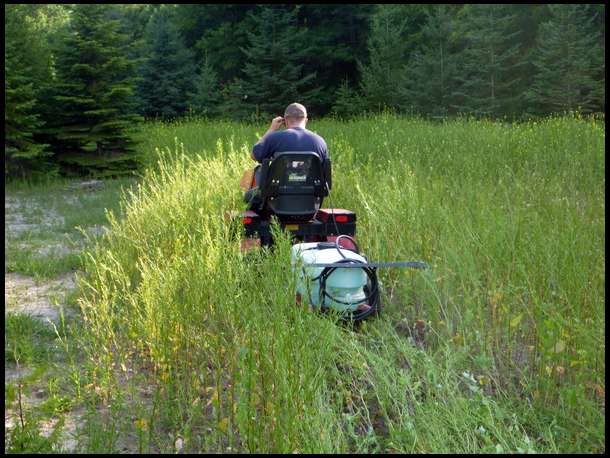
291,243,368,311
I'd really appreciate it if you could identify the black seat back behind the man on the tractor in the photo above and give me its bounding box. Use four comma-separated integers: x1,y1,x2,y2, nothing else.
260,152,332,221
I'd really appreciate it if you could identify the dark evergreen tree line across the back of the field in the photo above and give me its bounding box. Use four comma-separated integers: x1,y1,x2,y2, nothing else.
4,4,605,176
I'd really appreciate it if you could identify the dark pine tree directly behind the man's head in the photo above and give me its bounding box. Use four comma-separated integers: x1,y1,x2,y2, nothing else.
234,5,320,119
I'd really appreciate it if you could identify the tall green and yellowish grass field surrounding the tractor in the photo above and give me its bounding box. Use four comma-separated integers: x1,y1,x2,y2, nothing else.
75,115,605,453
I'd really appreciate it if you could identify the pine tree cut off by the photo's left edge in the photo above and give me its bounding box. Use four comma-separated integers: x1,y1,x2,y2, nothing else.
4,5,53,177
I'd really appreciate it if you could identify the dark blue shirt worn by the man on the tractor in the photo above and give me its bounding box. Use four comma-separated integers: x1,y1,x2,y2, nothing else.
252,127,328,162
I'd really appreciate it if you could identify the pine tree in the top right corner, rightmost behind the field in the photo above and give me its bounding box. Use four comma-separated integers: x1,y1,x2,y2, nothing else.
527,4,605,114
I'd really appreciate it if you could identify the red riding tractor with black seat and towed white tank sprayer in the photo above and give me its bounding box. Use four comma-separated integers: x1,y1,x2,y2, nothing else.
226,152,426,322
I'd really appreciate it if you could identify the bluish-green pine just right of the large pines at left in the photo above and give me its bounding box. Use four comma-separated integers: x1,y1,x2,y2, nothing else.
138,6,195,118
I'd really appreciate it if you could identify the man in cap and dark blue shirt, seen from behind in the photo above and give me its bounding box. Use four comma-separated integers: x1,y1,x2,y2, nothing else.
241,103,328,203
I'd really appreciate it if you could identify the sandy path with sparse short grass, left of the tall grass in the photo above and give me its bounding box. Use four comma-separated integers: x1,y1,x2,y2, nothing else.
4,180,138,453
